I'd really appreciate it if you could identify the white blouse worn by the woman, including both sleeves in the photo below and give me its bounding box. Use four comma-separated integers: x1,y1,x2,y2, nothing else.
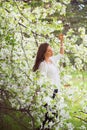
39,54,63,90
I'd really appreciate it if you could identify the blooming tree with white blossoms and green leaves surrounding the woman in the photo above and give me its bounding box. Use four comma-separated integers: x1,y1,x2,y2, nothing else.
0,0,87,130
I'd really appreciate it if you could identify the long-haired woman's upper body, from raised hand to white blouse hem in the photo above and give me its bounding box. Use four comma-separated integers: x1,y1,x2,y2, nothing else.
33,34,64,90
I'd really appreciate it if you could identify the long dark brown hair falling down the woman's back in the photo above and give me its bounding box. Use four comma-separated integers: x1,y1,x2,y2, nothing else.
33,43,49,72
